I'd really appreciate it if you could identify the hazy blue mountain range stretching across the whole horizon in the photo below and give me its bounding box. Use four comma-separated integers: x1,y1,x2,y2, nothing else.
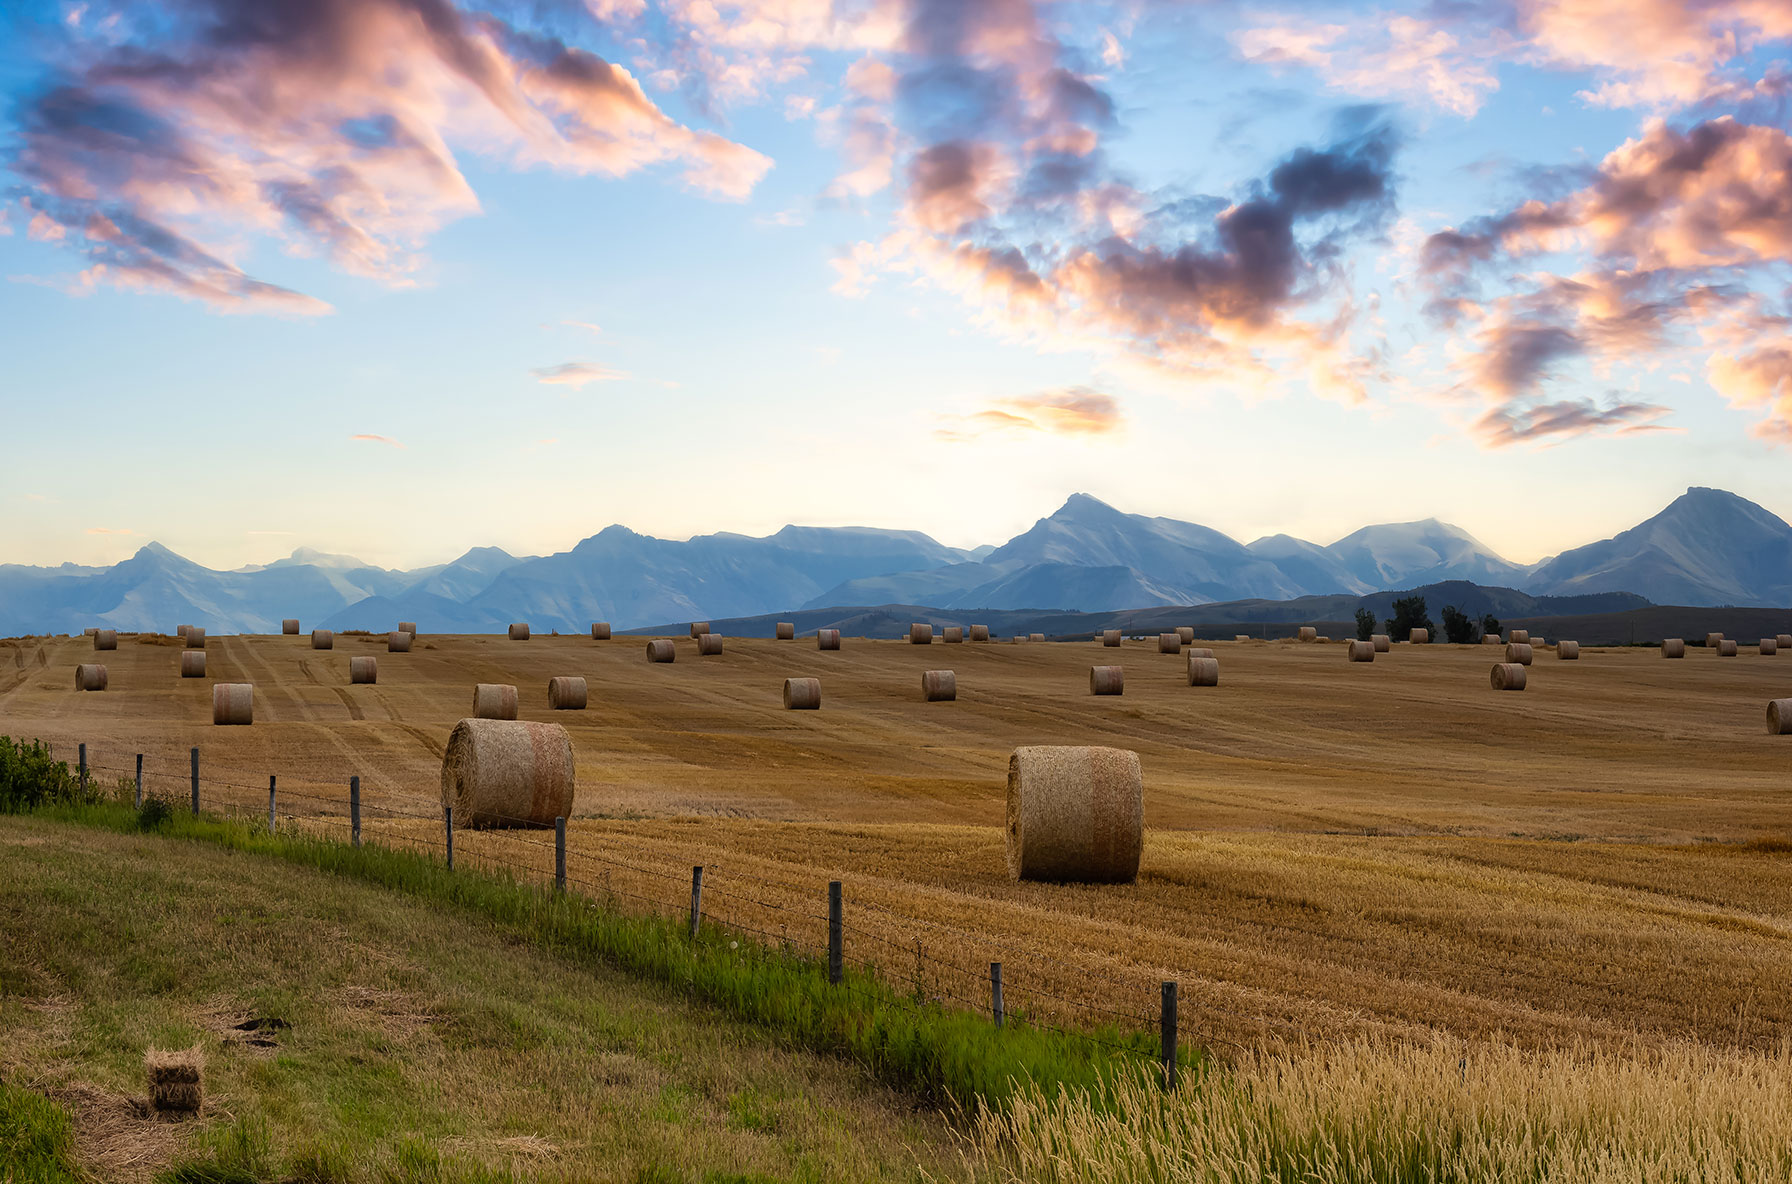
0,487,1792,636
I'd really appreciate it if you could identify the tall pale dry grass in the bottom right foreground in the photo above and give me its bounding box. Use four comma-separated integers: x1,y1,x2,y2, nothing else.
973,1039,1792,1184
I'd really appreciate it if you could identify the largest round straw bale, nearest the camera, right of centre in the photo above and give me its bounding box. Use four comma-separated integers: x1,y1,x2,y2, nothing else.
1007,745,1145,883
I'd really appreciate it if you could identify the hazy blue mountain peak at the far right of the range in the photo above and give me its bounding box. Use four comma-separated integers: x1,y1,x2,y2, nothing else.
1525,485,1792,607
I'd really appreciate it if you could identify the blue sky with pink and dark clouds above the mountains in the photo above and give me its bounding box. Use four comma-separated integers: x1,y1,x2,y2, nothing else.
0,0,1792,568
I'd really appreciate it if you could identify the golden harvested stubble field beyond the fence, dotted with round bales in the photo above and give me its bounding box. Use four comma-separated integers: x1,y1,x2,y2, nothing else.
0,634,1792,1051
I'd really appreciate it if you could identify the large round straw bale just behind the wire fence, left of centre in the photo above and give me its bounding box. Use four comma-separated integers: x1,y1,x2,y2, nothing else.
443,716,577,828
